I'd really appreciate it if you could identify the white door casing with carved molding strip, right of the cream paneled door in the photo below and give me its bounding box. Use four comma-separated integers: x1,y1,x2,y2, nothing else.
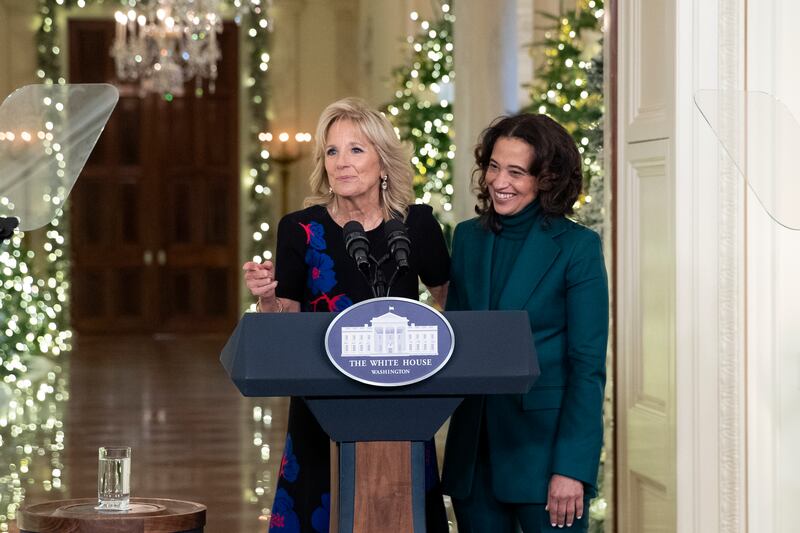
675,0,752,533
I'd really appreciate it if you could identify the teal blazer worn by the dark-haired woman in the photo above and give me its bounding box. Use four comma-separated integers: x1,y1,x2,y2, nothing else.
442,213,608,503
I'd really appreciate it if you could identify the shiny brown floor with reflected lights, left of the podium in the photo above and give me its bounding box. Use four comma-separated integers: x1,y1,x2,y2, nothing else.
0,337,454,533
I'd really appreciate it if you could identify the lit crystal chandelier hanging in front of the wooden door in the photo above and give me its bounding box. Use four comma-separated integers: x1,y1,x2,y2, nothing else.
111,0,250,96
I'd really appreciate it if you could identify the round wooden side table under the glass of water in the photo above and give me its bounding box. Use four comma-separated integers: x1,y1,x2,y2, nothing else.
17,498,206,533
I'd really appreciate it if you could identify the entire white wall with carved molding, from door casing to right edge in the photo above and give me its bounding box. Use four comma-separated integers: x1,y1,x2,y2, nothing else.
676,0,800,533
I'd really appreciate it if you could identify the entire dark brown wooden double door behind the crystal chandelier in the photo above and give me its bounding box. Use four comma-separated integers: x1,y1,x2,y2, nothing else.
69,20,239,333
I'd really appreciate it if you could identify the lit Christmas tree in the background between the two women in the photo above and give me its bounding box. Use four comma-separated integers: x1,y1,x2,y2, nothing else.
386,2,456,241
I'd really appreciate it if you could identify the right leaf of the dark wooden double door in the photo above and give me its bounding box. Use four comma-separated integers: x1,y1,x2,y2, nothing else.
154,39,239,330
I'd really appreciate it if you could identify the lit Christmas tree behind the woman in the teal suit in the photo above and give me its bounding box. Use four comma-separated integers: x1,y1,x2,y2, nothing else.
525,0,604,235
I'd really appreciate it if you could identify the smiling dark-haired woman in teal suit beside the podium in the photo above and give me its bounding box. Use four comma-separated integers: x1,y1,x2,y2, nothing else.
442,114,608,533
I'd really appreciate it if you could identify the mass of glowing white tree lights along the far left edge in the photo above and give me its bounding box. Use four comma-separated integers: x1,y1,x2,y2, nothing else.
0,225,71,531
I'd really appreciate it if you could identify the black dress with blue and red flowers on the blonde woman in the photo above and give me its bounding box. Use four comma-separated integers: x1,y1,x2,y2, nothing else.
269,205,450,533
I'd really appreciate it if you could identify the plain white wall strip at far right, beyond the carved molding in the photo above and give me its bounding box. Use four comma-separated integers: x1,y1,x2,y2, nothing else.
747,0,800,533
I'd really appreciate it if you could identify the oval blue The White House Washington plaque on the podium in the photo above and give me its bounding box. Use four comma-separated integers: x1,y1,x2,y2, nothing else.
325,298,455,387
